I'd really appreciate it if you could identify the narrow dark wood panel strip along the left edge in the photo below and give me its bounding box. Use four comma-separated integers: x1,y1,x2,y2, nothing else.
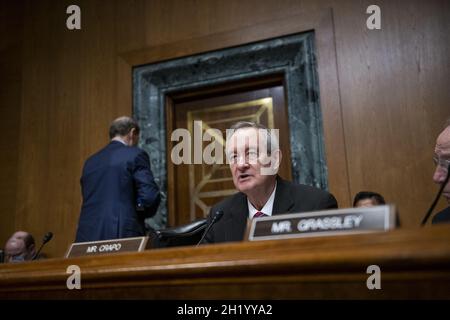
0,1,24,248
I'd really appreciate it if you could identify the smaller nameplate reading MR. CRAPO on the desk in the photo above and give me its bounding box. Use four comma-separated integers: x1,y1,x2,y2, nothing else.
66,237,148,258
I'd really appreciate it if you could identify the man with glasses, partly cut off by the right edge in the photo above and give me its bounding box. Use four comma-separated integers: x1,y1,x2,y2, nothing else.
431,120,450,224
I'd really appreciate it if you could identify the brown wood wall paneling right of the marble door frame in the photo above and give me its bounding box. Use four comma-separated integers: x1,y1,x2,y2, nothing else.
335,1,450,226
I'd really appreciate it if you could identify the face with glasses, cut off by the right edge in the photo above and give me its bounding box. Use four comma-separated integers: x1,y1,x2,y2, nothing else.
433,126,450,203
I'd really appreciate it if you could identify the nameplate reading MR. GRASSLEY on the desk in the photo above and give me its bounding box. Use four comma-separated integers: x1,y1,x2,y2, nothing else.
248,205,395,241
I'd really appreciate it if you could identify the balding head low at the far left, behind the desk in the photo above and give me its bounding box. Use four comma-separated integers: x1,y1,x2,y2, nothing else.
4,231,36,262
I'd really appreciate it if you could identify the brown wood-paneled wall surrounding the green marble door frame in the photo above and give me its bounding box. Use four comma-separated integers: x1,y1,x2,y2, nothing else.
0,0,450,256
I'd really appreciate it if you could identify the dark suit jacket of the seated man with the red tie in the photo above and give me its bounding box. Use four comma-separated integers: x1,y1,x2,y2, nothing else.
203,177,337,243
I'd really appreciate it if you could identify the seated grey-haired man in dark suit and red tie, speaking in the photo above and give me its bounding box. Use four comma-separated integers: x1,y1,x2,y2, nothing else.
204,122,337,243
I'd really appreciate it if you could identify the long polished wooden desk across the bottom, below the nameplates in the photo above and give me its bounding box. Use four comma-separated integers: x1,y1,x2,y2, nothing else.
0,225,450,299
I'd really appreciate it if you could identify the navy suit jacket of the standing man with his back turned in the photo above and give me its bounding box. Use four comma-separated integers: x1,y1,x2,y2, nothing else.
76,141,160,242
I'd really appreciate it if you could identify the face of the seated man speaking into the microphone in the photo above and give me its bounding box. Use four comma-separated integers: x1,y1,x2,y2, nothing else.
227,128,281,194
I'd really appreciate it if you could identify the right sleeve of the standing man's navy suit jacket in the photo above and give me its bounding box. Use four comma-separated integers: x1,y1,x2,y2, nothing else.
133,150,161,218
